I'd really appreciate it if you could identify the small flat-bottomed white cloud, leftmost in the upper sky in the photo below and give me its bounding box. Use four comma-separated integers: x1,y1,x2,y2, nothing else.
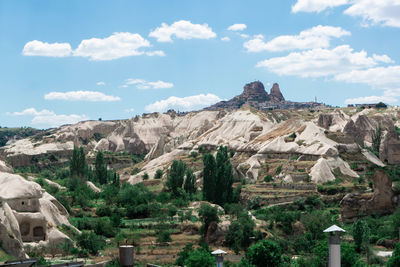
22,40,72,57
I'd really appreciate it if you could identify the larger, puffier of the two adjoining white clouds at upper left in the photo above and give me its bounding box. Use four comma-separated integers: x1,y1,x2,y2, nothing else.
73,32,150,60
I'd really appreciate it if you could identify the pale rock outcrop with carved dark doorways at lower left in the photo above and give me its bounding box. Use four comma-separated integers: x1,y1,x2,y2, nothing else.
0,172,75,258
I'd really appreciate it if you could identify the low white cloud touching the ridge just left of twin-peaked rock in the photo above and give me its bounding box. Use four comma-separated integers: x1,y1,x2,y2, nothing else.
145,94,221,112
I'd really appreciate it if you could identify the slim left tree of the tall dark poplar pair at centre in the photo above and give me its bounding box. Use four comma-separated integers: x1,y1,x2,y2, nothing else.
203,153,217,202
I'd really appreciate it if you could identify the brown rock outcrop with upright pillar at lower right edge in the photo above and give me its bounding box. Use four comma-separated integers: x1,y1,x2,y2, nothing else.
340,169,398,222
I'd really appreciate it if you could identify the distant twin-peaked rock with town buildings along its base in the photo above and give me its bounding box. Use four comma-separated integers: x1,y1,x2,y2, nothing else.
205,81,326,110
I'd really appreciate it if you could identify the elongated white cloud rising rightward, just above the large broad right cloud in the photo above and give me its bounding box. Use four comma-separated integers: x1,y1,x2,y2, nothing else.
243,25,350,52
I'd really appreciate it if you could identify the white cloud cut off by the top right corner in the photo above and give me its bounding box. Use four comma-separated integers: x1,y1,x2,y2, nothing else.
344,0,400,27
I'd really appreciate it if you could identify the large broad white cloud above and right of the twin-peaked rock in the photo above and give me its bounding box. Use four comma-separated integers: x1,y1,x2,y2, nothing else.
256,45,384,77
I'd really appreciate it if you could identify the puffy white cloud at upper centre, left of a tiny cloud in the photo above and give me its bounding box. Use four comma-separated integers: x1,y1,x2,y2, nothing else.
149,20,217,42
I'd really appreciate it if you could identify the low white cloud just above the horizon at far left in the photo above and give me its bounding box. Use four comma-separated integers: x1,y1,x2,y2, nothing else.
9,108,89,127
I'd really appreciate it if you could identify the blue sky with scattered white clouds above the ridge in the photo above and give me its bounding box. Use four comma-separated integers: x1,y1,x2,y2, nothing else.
0,0,400,128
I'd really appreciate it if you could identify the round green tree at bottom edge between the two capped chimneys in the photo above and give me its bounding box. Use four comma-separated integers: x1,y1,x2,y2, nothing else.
246,239,282,267
